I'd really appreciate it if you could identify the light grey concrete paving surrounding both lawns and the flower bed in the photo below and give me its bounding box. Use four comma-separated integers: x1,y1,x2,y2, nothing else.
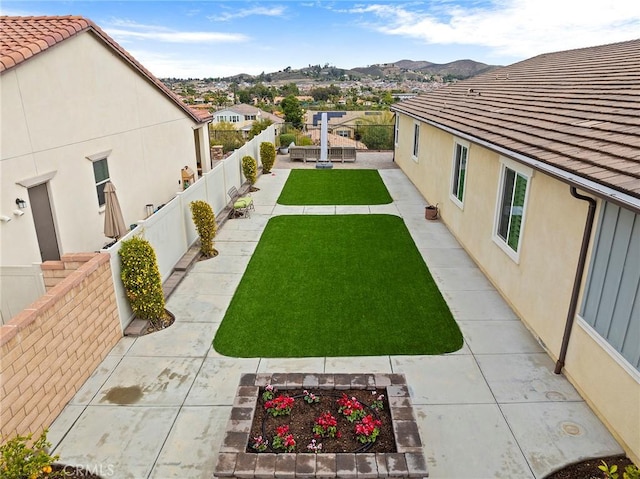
49,165,623,479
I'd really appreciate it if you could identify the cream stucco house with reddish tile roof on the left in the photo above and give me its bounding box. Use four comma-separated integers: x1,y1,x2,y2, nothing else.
0,16,211,321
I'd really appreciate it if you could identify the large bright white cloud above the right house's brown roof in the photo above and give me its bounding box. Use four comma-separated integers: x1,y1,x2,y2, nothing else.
350,0,640,58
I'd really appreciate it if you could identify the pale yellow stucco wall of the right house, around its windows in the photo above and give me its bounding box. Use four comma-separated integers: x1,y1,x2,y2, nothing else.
395,115,640,461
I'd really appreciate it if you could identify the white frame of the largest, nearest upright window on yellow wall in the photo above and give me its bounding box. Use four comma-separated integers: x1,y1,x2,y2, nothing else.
492,157,533,264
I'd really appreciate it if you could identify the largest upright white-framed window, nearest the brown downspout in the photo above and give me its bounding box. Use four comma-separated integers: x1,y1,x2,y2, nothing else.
494,159,533,261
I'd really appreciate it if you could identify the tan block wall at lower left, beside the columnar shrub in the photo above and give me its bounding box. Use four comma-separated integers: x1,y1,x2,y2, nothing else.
0,253,122,441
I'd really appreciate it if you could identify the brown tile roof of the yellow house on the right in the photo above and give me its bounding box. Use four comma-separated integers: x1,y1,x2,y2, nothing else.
392,40,640,209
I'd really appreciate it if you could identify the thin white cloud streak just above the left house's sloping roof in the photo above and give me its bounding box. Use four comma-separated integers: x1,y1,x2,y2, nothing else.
103,19,248,43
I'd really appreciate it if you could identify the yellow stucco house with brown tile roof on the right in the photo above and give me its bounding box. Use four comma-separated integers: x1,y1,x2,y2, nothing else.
392,40,640,463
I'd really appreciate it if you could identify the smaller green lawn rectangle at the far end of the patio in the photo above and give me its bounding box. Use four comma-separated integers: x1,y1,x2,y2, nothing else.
278,169,392,205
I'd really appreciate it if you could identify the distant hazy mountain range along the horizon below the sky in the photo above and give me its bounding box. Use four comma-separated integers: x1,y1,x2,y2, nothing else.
221,60,498,83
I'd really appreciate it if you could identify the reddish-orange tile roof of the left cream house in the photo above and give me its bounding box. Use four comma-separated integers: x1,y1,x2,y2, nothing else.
0,16,211,123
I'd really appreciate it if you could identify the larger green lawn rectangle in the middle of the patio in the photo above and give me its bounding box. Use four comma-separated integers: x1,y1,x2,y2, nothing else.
213,215,462,357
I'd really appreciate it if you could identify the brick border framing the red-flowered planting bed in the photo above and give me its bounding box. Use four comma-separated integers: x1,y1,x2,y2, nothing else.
213,373,429,479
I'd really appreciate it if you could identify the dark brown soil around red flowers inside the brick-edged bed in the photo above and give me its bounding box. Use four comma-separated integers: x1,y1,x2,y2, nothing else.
246,388,396,453
